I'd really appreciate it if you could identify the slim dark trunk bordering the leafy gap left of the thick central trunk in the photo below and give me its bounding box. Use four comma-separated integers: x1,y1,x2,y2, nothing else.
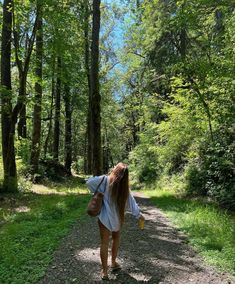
64,84,72,175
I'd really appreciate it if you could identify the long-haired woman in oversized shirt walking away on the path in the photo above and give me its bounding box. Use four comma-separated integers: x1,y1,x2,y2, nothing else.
86,163,144,280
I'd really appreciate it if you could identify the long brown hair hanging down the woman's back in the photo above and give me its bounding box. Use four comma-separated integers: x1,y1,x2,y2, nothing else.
110,163,129,225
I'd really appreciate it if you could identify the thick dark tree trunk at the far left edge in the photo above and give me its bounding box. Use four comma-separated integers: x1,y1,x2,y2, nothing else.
1,0,17,192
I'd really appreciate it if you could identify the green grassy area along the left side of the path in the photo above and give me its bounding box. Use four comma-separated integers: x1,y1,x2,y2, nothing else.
0,178,89,284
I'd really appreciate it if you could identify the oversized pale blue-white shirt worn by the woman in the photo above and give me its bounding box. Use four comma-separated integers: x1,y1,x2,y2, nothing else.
86,175,140,232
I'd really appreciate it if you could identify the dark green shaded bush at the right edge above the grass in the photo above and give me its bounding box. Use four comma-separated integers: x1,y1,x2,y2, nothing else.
185,127,235,209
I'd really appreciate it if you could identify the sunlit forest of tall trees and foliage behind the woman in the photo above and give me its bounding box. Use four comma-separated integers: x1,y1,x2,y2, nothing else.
0,0,235,283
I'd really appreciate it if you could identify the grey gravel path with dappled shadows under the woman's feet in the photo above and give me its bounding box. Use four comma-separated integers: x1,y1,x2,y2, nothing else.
39,194,235,284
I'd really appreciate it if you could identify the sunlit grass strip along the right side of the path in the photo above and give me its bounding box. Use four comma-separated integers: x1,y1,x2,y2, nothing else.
145,187,235,275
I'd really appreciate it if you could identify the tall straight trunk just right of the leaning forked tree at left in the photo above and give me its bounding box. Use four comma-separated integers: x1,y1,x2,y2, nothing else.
30,2,43,172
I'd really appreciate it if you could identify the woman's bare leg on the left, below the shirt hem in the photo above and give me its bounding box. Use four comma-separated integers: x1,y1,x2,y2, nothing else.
98,220,110,277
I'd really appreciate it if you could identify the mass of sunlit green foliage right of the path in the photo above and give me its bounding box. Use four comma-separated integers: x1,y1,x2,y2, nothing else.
119,0,235,209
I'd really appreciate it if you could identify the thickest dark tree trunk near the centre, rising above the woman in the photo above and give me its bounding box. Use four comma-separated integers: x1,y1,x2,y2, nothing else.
90,0,102,175
